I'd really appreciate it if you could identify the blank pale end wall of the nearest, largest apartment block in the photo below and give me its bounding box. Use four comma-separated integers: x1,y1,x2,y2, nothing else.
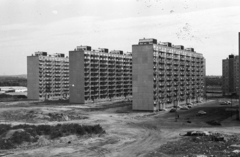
132,45,153,111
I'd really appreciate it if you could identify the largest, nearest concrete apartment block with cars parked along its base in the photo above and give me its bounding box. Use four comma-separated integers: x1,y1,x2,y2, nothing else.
132,39,205,111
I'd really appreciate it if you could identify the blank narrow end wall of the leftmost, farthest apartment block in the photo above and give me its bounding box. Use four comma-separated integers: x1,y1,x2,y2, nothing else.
27,56,39,99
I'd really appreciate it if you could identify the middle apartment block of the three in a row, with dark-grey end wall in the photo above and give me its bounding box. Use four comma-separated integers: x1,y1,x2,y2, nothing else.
69,46,132,104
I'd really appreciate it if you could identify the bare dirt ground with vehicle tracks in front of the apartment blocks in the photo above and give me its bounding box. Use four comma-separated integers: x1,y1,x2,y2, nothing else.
0,100,240,157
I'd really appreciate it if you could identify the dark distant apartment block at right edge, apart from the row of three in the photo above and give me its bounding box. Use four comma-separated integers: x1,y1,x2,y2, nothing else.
222,55,239,95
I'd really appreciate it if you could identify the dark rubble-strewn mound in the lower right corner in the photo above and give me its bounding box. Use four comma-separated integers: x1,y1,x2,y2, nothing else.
158,131,240,157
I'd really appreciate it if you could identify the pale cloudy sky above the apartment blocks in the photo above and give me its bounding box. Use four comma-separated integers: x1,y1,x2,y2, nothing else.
0,0,240,75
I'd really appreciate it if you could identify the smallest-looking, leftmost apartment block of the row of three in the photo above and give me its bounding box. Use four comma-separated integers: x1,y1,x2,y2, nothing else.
27,52,69,99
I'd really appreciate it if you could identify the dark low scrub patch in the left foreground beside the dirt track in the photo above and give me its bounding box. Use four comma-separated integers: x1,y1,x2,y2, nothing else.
0,124,105,149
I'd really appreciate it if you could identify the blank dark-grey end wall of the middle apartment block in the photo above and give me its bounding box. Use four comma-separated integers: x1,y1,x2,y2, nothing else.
69,50,85,104
